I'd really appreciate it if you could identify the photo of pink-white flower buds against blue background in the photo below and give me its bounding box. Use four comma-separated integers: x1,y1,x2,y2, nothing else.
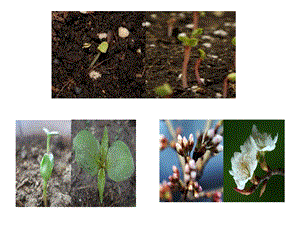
160,120,223,202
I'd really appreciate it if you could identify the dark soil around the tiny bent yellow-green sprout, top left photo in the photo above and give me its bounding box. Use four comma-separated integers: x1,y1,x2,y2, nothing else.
52,12,145,98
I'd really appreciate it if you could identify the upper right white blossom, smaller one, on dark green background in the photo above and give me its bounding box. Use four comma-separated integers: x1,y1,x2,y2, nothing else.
251,125,278,151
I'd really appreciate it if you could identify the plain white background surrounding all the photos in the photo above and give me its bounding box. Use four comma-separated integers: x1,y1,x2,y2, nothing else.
0,0,300,225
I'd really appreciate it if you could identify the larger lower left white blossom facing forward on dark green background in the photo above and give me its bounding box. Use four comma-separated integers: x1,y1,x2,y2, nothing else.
229,149,258,190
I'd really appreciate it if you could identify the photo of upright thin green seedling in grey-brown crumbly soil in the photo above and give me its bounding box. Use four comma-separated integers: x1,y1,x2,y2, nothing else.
16,120,71,207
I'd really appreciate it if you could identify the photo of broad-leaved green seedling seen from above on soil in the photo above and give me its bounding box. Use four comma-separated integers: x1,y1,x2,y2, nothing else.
71,120,136,207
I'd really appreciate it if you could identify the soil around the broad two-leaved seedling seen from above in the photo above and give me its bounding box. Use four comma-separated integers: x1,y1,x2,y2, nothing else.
71,120,136,207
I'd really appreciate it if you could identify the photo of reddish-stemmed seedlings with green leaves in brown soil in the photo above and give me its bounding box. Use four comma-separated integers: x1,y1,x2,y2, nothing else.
145,11,236,98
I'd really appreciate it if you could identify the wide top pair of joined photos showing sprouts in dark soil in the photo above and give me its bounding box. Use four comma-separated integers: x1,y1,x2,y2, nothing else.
52,11,236,98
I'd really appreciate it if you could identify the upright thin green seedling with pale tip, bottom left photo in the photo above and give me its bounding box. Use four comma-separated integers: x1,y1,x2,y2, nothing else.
40,128,58,207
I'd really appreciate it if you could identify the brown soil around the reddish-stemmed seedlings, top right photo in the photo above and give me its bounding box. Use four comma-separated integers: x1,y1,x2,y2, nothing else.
145,12,236,98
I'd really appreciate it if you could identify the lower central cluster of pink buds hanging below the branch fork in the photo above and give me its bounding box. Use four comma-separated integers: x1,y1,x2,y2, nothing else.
184,158,202,198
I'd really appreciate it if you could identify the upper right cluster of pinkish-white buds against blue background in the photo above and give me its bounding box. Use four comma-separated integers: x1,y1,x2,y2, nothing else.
193,128,223,161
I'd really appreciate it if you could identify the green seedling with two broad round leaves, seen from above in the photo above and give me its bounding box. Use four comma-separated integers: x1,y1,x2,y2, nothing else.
73,127,134,203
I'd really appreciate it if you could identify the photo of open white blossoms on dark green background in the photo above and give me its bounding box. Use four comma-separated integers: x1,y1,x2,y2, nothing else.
224,120,284,202
